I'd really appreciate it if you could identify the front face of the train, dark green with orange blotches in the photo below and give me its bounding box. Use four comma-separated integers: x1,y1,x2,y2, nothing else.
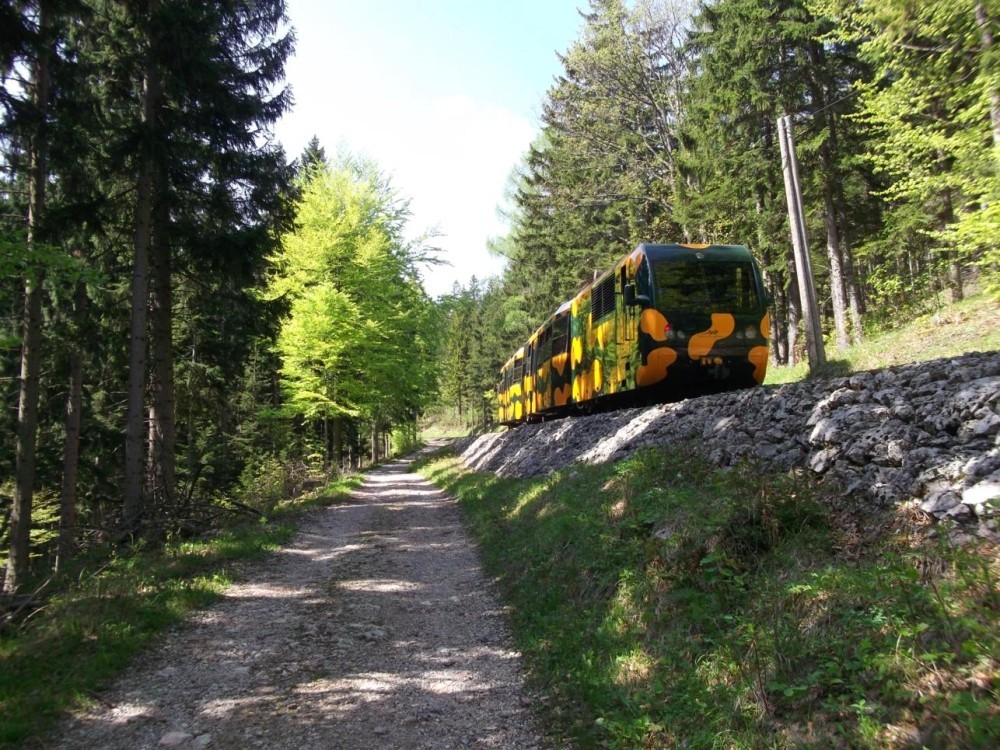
636,245,770,391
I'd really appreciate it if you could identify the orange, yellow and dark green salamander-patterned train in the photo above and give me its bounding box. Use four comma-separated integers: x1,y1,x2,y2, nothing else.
496,243,771,426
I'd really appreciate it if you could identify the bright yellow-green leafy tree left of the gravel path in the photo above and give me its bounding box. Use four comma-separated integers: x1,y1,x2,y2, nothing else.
269,160,433,428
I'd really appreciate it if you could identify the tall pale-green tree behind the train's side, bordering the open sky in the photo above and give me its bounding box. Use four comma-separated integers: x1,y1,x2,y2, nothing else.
503,0,700,336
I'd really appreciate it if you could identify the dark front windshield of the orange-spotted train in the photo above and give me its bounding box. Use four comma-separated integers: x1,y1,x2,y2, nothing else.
653,258,760,314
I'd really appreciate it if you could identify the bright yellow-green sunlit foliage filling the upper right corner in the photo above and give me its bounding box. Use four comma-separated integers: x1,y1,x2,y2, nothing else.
815,0,1000,300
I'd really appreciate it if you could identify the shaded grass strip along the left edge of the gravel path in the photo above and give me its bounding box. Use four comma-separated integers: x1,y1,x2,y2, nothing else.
0,478,357,747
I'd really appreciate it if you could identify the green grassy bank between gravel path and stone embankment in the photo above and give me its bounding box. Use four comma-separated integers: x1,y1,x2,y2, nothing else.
422,447,1000,748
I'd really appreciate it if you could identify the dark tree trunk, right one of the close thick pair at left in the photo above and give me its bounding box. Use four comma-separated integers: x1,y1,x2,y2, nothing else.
146,200,177,524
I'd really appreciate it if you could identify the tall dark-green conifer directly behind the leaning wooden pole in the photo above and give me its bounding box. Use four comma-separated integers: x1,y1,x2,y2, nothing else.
680,0,865,362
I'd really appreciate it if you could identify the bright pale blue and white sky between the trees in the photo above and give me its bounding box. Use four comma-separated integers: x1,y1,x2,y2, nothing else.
275,0,588,297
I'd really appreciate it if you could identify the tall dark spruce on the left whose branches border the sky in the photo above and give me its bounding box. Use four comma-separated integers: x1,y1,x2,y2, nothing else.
64,0,292,528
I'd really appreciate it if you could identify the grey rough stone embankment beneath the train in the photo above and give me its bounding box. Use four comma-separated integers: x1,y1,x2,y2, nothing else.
459,352,1000,536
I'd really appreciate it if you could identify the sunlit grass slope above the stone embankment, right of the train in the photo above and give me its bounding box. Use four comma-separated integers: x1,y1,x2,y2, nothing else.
765,286,1000,384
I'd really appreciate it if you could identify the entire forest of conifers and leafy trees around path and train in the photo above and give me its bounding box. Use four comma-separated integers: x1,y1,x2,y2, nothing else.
0,0,1000,591
